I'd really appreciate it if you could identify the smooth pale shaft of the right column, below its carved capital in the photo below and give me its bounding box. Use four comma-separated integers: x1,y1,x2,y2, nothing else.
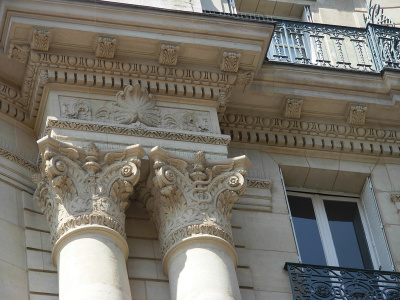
167,237,241,300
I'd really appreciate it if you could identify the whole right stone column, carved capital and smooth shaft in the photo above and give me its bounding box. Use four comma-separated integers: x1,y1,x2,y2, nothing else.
146,147,250,300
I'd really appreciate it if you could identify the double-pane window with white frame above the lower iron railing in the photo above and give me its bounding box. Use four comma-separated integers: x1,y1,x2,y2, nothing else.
287,179,394,271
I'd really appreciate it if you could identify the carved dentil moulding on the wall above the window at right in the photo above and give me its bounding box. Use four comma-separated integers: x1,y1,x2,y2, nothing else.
219,113,400,157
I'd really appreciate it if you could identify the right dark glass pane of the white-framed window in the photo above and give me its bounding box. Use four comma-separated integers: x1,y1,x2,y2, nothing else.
324,200,373,269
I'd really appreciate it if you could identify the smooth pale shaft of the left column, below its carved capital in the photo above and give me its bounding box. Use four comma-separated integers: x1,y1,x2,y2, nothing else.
57,228,132,300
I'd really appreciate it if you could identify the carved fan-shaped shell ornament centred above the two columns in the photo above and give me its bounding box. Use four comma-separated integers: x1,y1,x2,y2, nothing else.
95,83,161,127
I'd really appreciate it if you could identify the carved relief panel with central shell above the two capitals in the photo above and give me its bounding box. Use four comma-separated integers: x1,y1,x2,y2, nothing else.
60,83,212,132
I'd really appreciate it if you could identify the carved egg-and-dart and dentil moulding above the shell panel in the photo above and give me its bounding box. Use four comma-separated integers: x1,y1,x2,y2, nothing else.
8,50,237,126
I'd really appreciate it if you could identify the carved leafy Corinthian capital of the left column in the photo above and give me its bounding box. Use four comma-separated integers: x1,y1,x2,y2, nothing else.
33,137,145,246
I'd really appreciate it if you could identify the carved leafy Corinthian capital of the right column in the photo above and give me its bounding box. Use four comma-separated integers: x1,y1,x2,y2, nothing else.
145,147,250,257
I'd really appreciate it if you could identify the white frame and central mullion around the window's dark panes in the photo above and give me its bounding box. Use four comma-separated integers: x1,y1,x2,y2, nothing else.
287,188,379,270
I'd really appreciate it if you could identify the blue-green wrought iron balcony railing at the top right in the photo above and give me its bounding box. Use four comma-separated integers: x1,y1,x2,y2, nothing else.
267,21,400,72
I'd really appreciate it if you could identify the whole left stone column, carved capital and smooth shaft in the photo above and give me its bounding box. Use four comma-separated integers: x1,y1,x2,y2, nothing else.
34,137,144,300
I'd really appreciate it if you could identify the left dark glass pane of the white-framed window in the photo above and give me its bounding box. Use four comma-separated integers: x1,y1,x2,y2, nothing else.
288,196,326,266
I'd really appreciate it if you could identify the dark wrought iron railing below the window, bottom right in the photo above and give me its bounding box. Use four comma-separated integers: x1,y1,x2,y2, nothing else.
285,263,400,300
